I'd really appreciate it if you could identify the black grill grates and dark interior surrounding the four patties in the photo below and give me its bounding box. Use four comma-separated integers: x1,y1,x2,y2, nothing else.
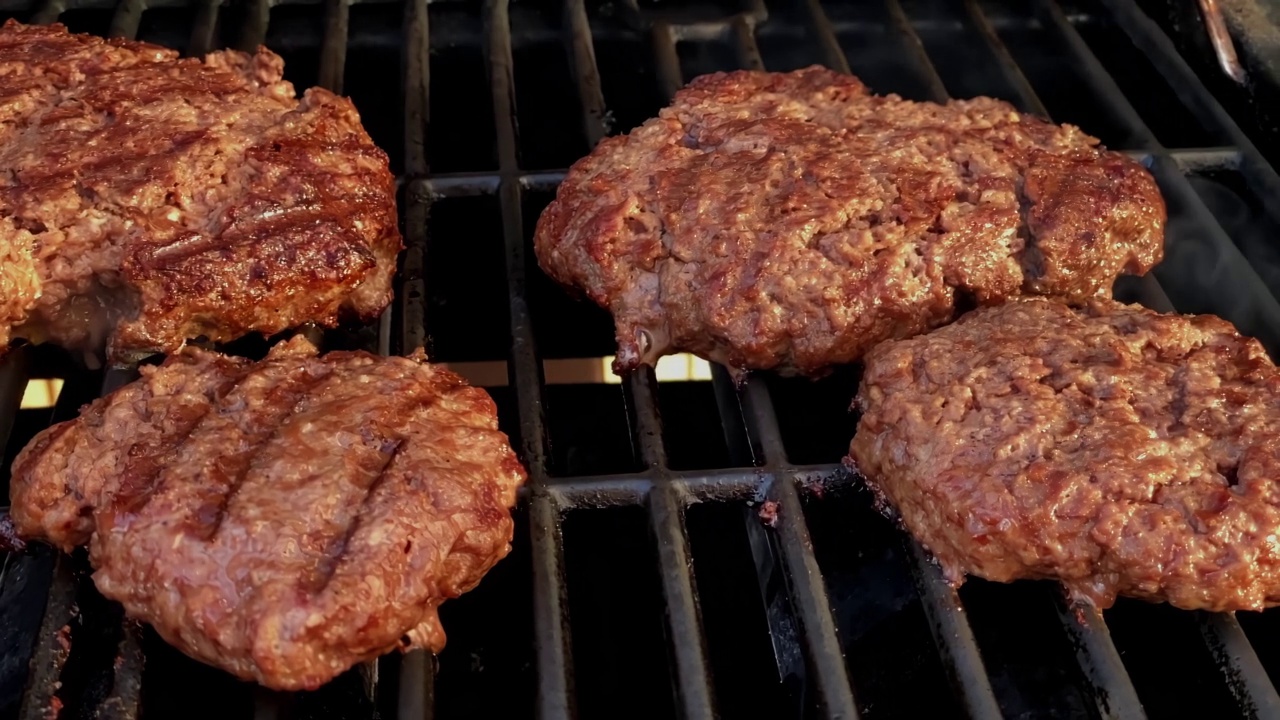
0,0,1280,719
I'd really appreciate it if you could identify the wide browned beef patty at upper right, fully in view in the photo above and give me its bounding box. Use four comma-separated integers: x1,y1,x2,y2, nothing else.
535,68,1165,374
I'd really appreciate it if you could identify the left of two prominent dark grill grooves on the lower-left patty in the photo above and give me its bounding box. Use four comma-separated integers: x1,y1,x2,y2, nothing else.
193,364,333,542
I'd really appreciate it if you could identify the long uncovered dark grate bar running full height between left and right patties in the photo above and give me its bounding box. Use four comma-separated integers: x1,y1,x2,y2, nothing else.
484,0,576,719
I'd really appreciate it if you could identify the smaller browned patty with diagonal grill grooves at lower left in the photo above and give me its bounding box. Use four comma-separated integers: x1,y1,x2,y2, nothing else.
10,341,525,689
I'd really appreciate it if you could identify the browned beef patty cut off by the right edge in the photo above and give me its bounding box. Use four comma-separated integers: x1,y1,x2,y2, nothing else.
851,299,1280,611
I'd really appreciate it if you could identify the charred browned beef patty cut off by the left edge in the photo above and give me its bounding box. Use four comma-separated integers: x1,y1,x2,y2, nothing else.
0,20,401,359
